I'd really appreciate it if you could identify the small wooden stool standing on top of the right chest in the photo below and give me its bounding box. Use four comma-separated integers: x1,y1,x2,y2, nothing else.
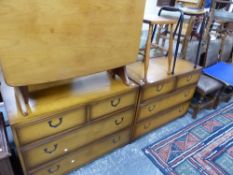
143,16,177,82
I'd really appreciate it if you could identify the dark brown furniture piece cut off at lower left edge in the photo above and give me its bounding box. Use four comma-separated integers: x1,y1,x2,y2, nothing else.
0,113,14,175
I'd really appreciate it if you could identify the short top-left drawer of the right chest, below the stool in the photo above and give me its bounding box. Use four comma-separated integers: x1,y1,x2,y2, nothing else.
142,78,176,101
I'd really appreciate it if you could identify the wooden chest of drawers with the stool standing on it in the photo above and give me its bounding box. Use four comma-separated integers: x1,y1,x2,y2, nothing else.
127,58,201,139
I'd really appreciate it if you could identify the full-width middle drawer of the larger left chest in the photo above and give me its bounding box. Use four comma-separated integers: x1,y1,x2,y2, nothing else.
22,109,134,169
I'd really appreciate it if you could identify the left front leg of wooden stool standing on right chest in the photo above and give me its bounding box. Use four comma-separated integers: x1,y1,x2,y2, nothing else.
144,24,153,82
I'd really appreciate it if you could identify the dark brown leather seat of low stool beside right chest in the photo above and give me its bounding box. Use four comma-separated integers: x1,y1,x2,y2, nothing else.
197,75,223,95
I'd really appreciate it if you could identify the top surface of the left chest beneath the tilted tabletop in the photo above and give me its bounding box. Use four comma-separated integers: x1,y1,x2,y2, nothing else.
1,72,137,124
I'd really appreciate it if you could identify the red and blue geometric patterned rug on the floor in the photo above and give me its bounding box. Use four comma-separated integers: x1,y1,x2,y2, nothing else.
143,103,233,175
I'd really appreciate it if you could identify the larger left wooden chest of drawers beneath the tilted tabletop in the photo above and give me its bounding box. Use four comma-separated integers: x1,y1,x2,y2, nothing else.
2,72,138,175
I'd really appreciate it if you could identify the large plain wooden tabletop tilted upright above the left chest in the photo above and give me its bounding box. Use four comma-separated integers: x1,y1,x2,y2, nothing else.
0,0,145,86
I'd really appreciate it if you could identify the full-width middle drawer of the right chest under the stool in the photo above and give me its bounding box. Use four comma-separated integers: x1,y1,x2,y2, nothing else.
138,86,196,120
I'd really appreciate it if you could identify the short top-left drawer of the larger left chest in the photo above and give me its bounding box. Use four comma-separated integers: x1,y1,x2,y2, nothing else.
16,108,86,145
